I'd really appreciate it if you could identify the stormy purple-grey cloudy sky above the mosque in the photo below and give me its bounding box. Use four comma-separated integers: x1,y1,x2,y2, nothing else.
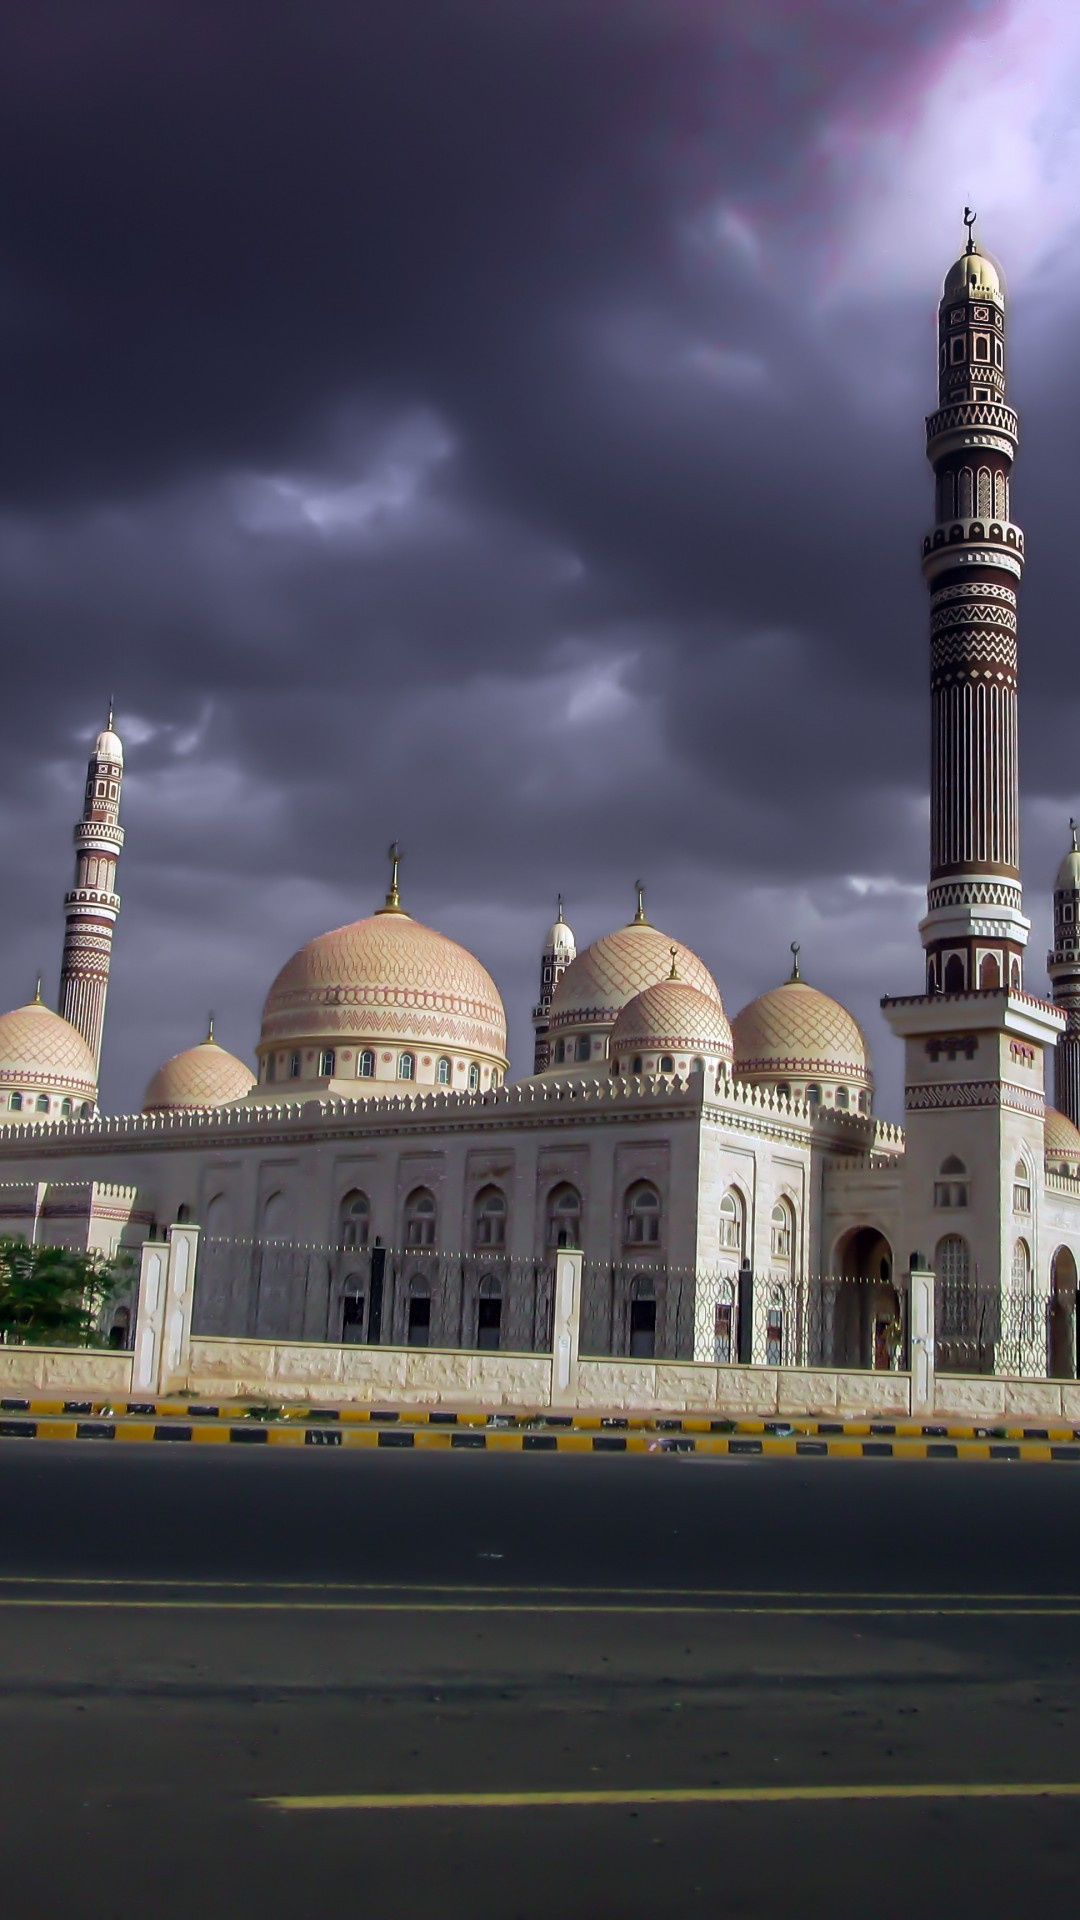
0,0,1080,1117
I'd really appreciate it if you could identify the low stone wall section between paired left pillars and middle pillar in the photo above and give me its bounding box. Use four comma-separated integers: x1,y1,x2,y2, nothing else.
181,1336,552,1407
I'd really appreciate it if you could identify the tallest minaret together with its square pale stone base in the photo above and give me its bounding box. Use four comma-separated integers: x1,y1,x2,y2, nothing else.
882,213,1065,1317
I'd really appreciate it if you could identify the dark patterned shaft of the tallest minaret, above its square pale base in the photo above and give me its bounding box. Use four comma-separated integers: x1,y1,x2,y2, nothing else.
920,215,1030,993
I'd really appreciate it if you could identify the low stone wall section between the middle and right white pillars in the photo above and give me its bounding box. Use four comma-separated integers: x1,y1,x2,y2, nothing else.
577,1359,911,1417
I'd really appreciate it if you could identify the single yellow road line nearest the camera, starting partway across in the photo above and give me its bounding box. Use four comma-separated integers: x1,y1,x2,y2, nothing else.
258,1780,1080,1812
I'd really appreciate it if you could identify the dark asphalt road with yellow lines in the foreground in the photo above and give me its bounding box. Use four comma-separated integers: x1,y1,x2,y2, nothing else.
0,1442,1080,1920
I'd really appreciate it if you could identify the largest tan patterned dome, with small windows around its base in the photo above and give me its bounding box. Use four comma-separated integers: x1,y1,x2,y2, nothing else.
259,910,507,1068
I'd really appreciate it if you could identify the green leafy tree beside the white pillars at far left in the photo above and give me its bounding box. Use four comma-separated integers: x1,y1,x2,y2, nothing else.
0,1238,131,1346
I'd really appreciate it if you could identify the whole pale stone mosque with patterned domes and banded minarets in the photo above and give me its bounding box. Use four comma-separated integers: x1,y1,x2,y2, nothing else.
0,217,1080,1377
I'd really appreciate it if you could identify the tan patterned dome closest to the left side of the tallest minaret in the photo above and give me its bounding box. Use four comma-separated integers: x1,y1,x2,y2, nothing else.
732,979,871,1087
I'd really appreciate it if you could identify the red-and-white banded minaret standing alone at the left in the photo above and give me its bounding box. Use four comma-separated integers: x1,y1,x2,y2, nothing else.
60,701,123,1066
